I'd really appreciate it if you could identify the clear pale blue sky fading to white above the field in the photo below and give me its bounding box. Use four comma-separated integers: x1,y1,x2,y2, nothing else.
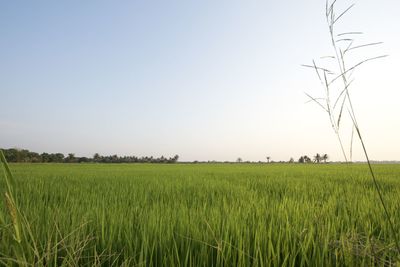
0,0,400,161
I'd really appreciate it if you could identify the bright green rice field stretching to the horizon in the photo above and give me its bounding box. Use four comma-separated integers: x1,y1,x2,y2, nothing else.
0,164,400,266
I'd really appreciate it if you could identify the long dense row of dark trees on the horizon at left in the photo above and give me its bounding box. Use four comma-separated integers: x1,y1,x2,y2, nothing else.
2,148,179,163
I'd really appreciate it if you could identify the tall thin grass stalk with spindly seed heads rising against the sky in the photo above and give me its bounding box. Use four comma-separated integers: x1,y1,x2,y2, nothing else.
303,0,400,253
